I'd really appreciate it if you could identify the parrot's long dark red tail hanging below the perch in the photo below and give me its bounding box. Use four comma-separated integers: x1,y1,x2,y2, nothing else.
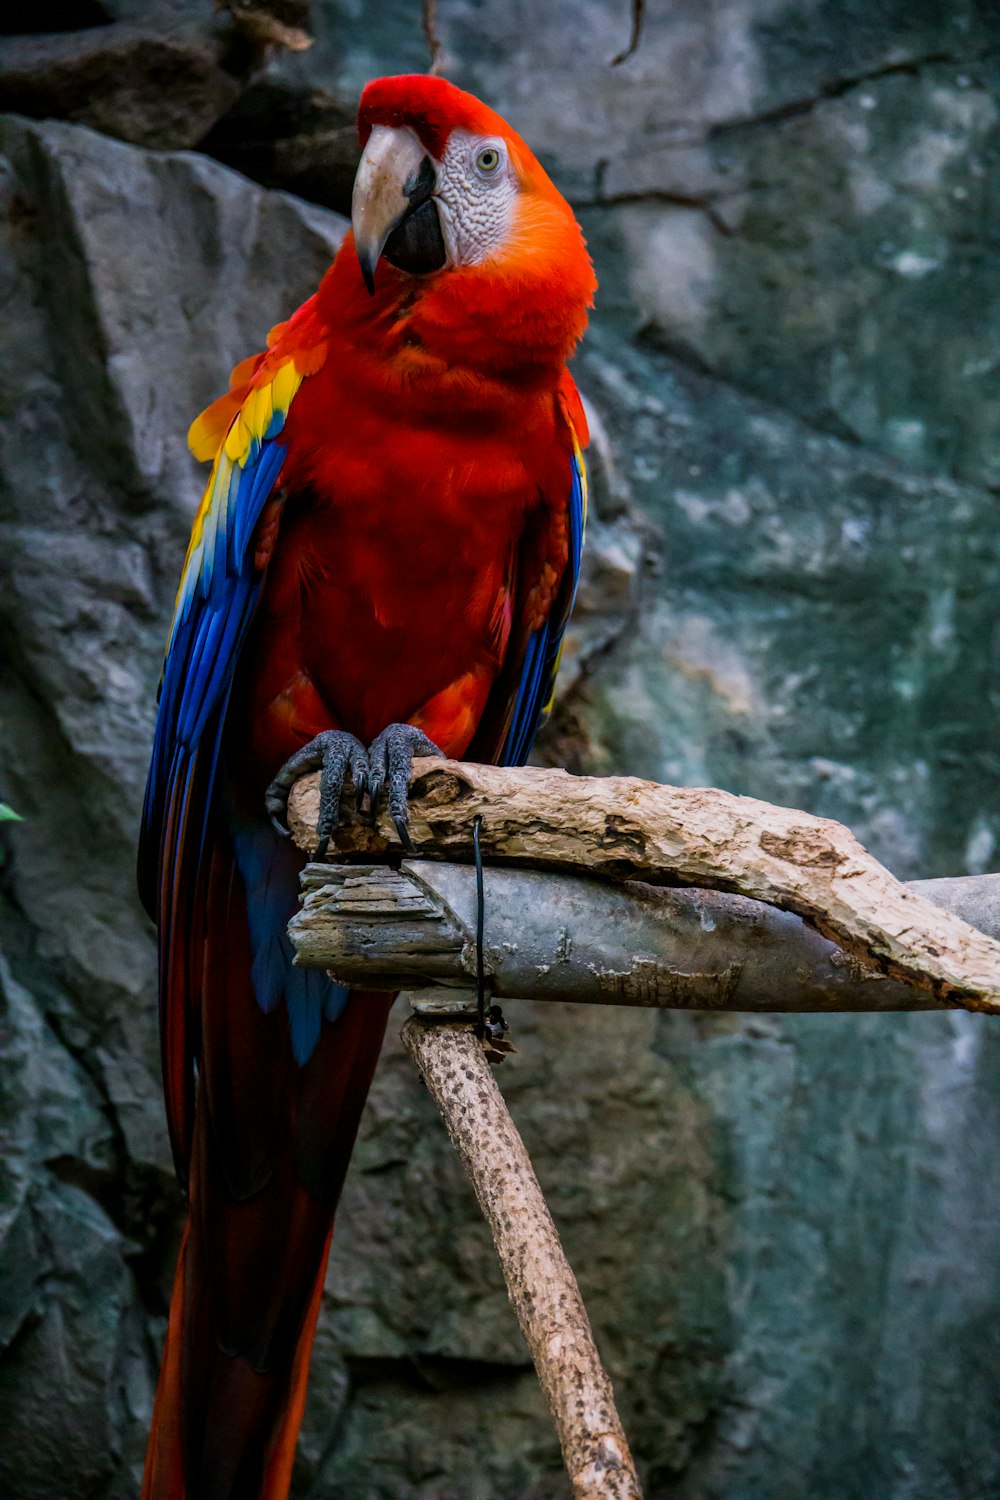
142,993,393,1500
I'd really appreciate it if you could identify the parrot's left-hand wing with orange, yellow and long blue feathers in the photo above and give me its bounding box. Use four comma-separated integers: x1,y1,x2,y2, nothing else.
138,305,325,1164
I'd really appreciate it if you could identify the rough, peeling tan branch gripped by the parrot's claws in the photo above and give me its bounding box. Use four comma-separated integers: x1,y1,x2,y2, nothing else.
289,761,1000,1011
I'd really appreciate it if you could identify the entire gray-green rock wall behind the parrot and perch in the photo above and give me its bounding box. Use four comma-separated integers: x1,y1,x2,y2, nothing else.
0,0,1000,1500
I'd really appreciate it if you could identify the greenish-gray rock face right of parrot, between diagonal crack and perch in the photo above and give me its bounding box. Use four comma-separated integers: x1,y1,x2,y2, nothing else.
566,330,1000,878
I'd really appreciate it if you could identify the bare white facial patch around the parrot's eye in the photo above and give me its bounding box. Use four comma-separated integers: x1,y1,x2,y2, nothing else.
435,131,519,266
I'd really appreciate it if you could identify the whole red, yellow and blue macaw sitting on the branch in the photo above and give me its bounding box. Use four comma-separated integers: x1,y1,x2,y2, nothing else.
138,74,597,1500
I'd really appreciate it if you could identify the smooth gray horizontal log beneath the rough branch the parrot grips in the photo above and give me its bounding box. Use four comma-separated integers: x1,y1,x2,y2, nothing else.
288,860,1000,1011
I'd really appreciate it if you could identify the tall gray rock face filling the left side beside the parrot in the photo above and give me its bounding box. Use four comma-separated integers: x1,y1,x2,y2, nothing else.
0,111,343,1500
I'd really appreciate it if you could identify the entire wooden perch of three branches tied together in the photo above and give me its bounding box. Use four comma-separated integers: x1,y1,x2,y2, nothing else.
289,761,1000,1500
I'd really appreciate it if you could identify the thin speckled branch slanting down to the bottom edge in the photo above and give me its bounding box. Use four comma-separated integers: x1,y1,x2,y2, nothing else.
402,1017,640,1500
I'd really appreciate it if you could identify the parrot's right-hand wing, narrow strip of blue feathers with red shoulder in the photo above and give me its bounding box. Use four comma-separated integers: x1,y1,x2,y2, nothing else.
469,375,586,765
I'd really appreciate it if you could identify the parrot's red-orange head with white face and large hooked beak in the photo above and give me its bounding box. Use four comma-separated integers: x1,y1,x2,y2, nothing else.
351,74,597,358
